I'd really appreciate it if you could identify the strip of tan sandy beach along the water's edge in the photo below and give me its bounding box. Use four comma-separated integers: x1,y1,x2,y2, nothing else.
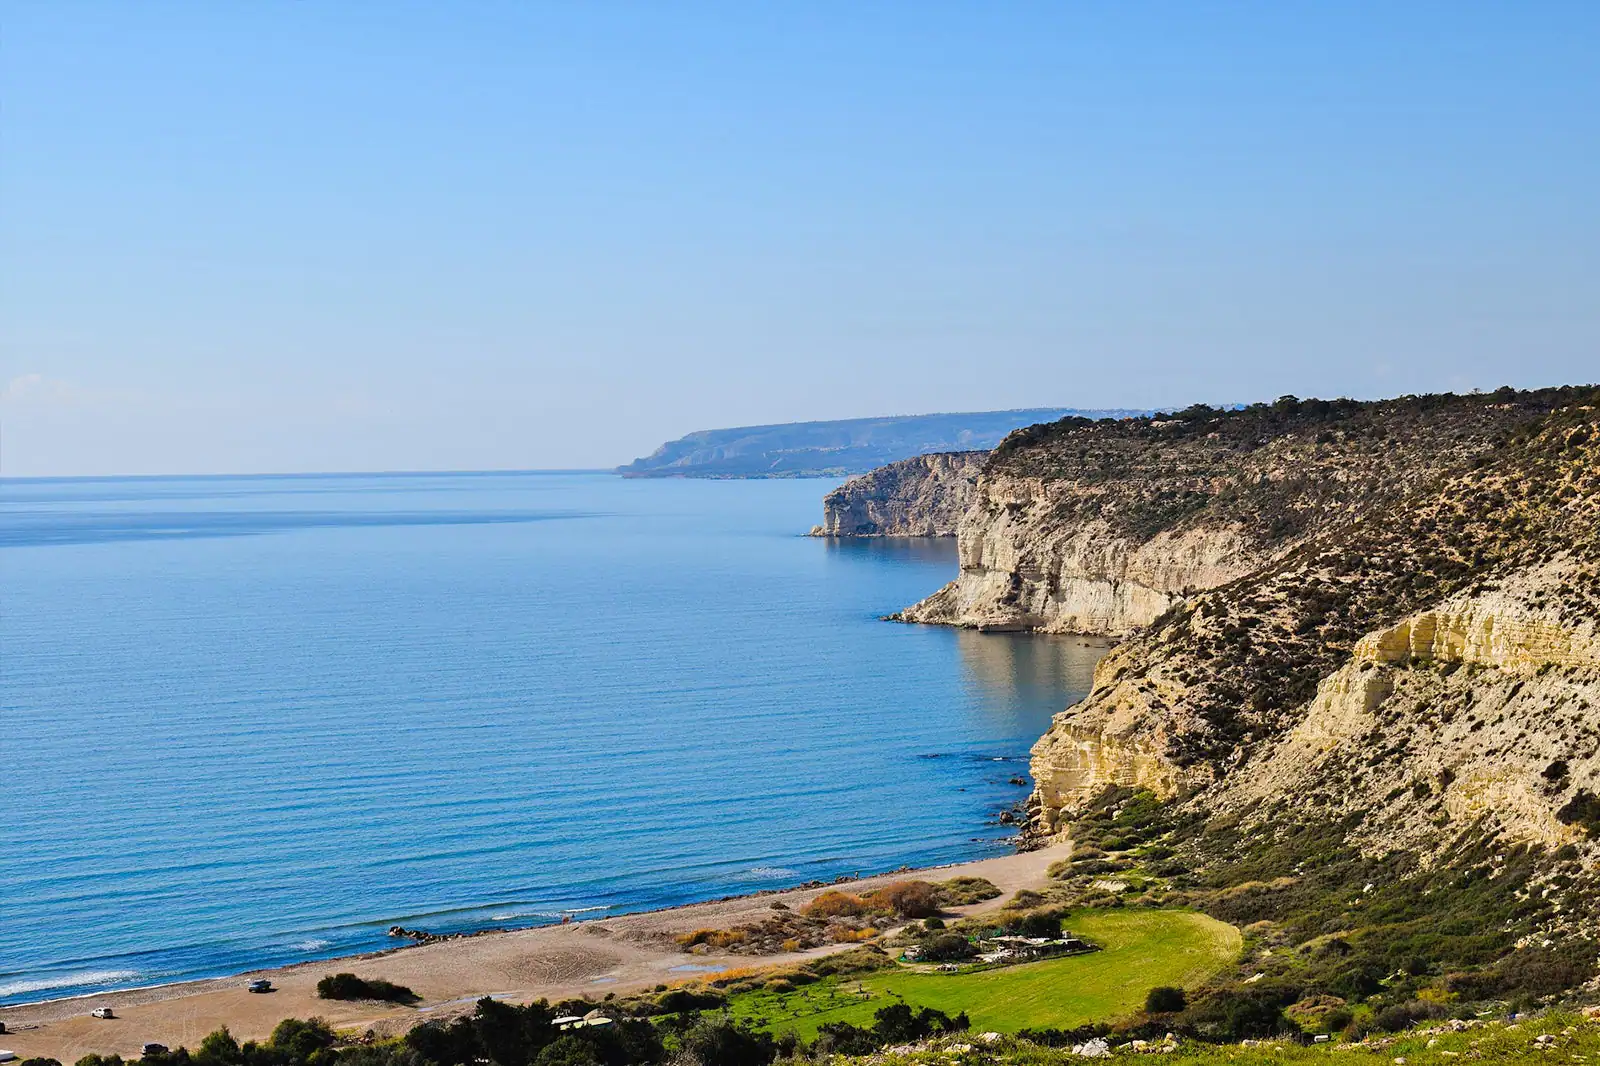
0,848,1062,1064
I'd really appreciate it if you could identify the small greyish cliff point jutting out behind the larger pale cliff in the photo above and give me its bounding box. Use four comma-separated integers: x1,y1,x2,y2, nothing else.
811,451,989,536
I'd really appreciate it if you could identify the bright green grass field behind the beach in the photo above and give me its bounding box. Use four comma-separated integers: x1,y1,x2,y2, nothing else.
730,908,1240,1039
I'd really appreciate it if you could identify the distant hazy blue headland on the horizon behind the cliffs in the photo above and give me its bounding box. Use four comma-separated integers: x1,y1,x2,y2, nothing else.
618,408,1134,477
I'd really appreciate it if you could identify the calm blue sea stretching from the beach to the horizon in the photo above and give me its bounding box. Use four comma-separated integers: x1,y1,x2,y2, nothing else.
0,474,1102,1004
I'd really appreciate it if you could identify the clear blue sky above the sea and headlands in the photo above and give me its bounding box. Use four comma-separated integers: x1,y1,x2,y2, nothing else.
0,0,1600,475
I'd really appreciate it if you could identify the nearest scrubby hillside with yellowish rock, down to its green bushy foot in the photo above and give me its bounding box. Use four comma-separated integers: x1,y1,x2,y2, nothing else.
1004,389,1600,1039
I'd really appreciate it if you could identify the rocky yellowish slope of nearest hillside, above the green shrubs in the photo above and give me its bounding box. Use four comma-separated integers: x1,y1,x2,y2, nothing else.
1032,394,1600,864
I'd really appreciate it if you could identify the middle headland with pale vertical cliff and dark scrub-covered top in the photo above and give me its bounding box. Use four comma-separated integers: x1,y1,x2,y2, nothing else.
901,394,1574,635
